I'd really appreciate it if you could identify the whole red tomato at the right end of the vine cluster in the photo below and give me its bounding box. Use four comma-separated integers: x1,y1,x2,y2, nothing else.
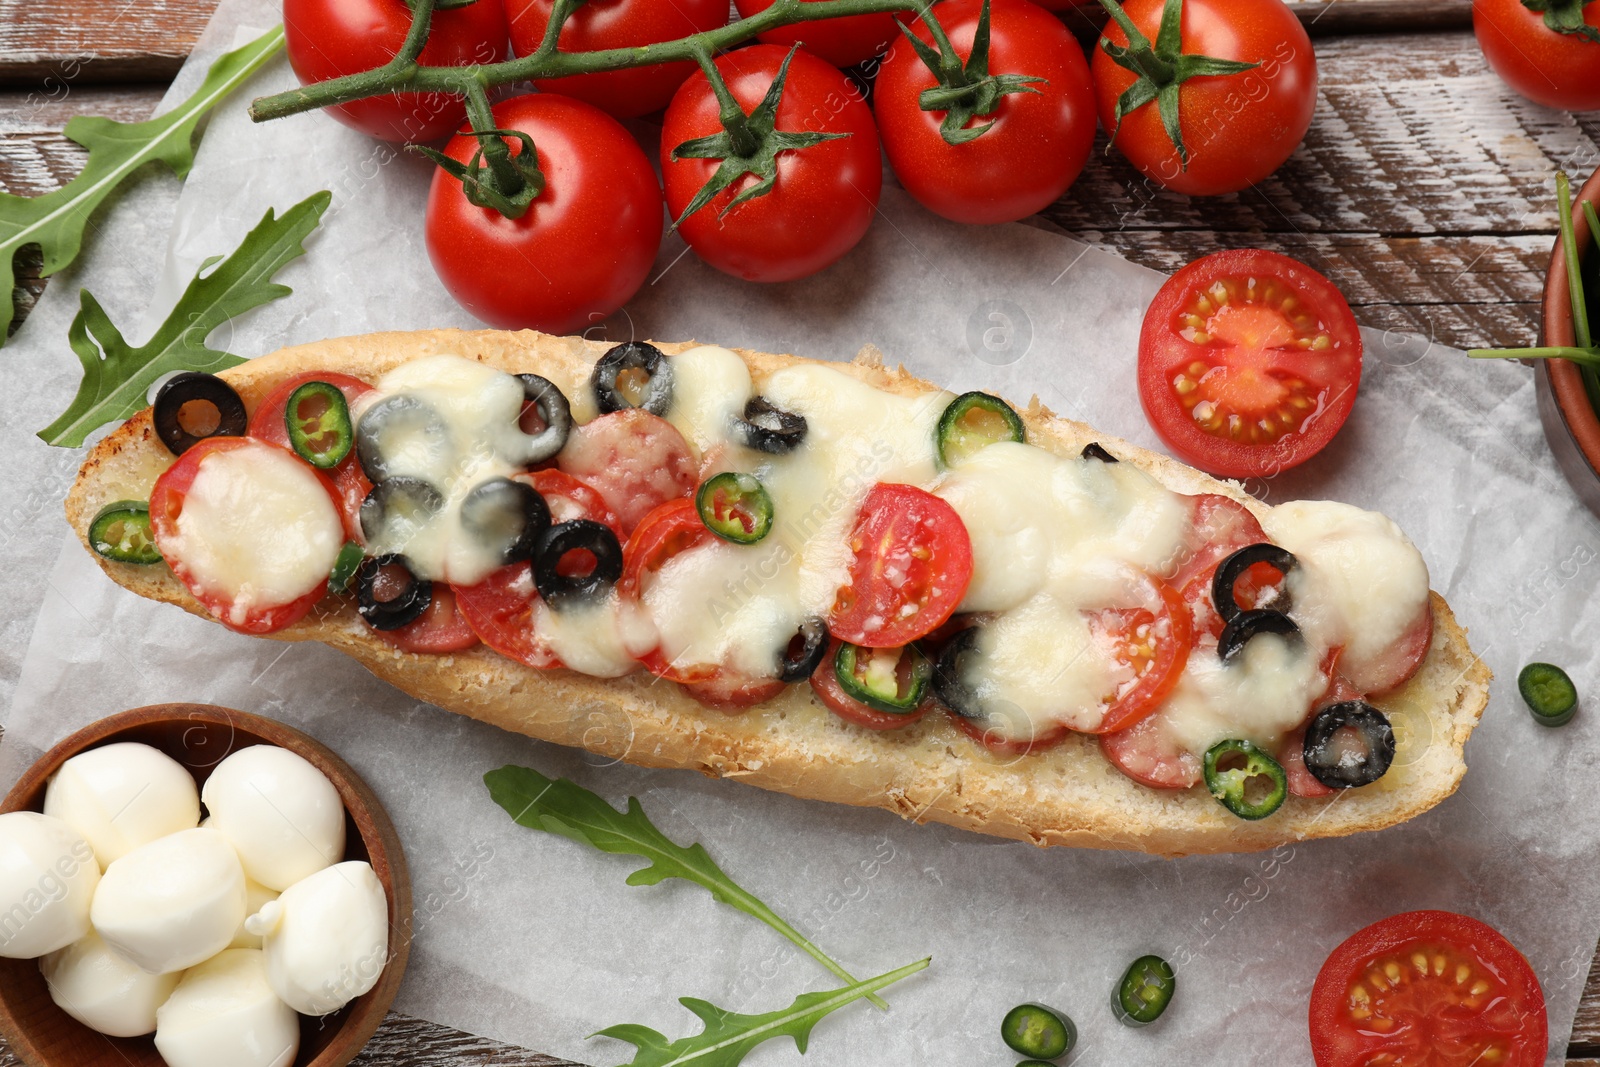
1091,0,1317,197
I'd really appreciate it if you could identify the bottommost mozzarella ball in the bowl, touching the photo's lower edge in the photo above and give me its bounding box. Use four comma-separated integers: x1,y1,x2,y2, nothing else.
155,949,299,1067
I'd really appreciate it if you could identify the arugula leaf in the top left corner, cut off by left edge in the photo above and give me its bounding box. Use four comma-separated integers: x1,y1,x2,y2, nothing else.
0,26,283,346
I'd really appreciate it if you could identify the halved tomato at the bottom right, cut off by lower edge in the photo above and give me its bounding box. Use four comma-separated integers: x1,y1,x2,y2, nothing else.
1310,912,1549,1067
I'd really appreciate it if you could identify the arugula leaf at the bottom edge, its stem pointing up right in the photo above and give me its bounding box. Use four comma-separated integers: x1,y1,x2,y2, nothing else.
590,957,933,1067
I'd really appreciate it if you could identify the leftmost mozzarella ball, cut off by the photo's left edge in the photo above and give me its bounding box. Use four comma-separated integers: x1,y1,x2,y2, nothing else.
0,811,101,960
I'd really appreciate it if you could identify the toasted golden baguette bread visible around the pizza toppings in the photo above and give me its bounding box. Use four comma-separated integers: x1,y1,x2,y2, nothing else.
66,331,1490,856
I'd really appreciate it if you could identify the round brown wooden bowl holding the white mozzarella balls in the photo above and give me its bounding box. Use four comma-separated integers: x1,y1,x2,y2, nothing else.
0,704,411,1067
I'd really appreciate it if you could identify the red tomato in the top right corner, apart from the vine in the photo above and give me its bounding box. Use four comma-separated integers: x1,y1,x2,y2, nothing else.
1472,0,1600,110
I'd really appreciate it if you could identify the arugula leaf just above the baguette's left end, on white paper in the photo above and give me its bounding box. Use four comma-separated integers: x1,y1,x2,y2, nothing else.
38,190,333,448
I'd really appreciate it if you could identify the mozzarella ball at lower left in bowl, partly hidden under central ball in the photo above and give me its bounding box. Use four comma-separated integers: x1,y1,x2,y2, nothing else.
38,931,181,1037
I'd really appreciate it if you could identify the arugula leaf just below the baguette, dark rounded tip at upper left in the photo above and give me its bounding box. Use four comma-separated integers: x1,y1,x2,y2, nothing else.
483,766,888,1008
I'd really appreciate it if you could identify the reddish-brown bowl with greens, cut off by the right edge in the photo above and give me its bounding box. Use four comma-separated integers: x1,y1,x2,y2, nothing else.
1536,163,1600,515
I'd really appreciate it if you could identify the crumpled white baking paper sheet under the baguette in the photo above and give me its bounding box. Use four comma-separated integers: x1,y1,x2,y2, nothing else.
0,0,1600,1067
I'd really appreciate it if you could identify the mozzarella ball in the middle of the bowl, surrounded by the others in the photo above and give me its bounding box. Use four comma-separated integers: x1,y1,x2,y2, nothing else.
90,829,245,974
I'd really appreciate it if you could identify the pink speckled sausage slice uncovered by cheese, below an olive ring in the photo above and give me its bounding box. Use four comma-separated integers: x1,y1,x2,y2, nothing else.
555,408,699,534
